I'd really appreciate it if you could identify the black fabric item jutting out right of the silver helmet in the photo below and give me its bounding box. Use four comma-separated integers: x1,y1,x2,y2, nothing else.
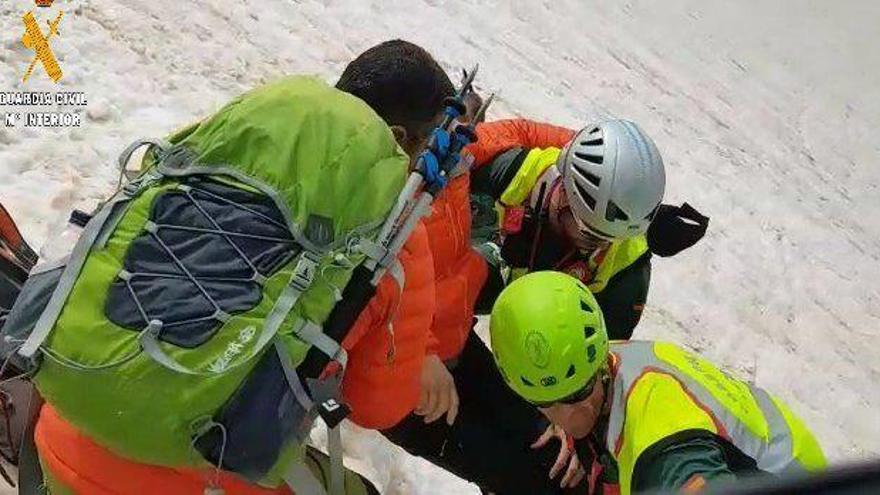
648,203,709,257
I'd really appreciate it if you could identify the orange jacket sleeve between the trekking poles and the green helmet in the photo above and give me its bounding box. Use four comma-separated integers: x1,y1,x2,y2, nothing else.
425,174,488,360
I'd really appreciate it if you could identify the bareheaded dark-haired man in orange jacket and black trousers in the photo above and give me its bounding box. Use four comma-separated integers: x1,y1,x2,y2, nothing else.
336,40,580,495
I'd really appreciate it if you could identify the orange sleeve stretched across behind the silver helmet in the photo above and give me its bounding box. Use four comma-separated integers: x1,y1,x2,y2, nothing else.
466,119,574,168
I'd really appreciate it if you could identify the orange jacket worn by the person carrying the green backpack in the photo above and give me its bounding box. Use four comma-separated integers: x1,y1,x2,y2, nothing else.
34,225,435,495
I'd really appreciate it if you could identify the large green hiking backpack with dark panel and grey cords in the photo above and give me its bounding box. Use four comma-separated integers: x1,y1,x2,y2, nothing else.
5,77,408,487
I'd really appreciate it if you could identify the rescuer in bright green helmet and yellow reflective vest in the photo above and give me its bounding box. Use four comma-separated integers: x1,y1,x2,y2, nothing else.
490,271,826,495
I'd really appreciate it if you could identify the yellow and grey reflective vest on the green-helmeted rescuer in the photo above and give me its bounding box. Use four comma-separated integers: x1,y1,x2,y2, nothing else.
606,341,825,494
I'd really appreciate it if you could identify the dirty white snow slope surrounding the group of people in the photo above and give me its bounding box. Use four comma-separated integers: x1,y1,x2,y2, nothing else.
0,0,880,494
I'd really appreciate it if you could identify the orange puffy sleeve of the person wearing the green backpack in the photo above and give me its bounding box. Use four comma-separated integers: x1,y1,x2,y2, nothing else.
342,224,436,429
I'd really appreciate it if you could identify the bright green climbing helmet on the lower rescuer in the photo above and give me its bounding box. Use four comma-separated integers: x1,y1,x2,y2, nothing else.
490,271,608,404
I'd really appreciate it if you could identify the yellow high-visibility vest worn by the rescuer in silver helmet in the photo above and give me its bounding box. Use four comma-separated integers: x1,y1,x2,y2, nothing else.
498,148,648,294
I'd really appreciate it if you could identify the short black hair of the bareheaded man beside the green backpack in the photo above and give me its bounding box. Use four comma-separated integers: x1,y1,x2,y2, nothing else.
336,40,455,138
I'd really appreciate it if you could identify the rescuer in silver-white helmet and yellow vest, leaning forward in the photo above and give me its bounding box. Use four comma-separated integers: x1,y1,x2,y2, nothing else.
470,120,708,339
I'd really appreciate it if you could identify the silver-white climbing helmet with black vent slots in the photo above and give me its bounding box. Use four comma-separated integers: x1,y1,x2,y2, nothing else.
556,120,666,240
